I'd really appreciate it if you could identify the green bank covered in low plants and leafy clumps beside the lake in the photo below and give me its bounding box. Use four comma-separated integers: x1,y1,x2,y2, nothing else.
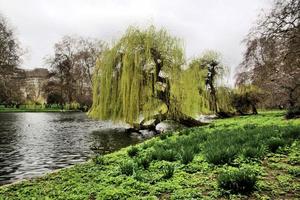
0,112,300,199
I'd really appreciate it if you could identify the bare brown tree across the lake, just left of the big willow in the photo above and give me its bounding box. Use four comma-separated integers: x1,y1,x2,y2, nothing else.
46,36,105,104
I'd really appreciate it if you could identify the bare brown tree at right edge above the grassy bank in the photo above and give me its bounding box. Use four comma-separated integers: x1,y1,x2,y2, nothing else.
237,0,300,107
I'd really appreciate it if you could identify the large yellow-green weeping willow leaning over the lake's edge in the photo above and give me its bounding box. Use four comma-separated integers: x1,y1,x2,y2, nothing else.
89,26,211,129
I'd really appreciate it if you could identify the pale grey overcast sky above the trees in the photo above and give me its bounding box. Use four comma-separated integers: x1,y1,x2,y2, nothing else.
0,0,271,83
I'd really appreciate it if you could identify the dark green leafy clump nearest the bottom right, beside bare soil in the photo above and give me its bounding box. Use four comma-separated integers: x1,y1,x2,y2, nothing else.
217,167,257,194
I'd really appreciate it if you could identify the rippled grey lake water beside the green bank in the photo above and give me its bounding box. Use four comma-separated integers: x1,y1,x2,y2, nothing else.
0,113,140,185
